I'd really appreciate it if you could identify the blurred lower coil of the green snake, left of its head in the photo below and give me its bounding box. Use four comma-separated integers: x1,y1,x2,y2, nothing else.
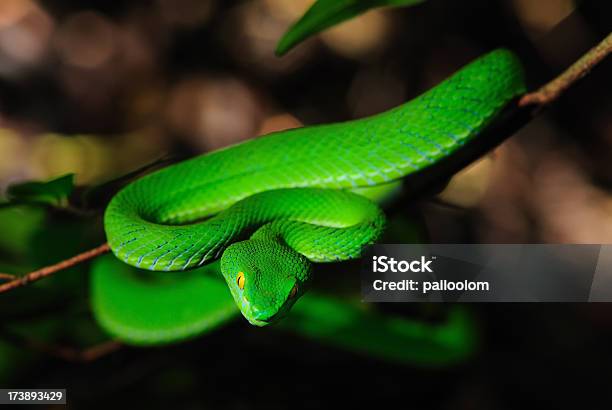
91,255,240,345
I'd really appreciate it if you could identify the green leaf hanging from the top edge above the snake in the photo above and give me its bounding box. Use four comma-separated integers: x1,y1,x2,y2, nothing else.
276,0,425,56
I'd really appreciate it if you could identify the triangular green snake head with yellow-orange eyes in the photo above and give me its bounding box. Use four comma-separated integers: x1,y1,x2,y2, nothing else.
221,239,312,326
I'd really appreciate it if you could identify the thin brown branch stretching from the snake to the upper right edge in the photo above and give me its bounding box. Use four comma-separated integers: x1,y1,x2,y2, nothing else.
519,33,612,107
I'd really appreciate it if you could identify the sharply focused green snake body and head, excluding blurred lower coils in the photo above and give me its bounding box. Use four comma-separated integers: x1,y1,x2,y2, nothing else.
104,49,525,326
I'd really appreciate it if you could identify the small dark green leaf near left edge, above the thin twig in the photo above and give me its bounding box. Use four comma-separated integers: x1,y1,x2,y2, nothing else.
6,174,74,206
